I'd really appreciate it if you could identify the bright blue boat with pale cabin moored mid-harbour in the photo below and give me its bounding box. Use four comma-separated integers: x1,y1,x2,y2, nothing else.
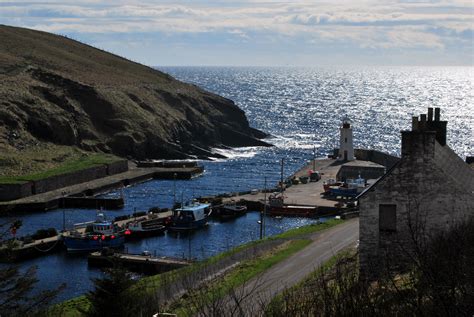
168,202,211,231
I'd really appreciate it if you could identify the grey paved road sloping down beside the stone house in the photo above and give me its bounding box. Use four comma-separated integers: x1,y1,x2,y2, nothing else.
220,218,359,316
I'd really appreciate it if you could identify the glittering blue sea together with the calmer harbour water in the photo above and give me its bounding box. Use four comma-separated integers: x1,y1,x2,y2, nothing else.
0,67,474,301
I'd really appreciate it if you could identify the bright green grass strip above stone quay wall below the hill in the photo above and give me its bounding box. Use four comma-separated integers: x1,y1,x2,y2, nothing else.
0,153,119,184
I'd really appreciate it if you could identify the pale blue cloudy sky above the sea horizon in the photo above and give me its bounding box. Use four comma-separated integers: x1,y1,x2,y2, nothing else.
0,0,474,66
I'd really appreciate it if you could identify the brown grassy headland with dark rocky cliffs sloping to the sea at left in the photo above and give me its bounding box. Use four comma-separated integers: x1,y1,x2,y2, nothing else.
0,26,268,159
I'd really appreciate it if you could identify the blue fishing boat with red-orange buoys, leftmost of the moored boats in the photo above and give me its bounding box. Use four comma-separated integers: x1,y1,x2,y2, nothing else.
62,213,125,252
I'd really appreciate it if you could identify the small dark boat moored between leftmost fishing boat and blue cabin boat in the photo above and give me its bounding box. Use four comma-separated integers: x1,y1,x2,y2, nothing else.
127,213,172,239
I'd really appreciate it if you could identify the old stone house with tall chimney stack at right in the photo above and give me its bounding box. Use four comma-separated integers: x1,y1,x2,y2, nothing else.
358,108,474,275
